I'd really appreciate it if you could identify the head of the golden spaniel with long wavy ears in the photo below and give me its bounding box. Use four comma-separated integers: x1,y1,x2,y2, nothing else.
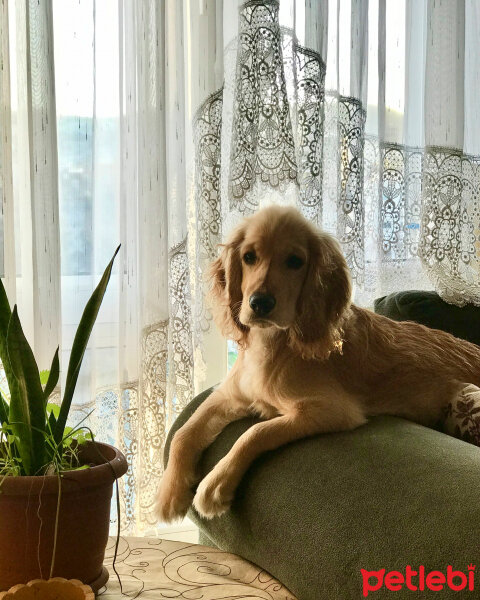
211,206,351,358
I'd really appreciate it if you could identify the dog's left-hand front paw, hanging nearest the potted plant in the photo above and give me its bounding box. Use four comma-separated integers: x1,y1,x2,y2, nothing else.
155,468,193,523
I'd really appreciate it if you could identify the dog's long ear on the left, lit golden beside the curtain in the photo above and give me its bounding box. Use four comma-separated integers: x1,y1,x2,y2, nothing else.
210,226,249,346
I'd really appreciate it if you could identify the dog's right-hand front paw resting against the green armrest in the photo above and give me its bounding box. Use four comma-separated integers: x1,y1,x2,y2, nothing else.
193,468,235,519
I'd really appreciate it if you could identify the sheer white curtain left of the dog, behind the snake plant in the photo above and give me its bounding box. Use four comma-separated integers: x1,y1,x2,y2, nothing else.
0,0,227,532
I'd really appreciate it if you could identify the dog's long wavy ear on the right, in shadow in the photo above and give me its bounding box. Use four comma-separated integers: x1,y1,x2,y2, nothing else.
290,232,352,359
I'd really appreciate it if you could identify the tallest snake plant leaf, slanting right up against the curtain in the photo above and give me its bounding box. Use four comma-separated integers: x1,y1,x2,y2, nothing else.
55,246,120,451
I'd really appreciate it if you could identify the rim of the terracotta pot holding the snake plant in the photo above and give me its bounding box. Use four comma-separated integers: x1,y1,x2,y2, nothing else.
0,440,128,494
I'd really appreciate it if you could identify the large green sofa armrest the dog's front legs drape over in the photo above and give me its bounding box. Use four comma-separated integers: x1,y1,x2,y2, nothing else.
165,390,480,600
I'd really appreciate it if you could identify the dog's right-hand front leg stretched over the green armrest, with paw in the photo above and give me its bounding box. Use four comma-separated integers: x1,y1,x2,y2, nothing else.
193,406,365,519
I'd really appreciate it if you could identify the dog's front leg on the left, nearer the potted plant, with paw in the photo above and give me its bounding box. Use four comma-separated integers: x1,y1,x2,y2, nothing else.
155,386,248,523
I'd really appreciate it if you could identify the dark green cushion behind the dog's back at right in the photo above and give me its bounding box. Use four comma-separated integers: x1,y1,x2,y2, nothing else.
374,290,480,345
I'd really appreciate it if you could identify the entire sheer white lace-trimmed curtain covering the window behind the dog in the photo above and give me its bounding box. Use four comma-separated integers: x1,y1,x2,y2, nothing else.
0,0,480,533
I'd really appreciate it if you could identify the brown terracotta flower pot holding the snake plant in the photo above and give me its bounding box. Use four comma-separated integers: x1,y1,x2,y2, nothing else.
0,442,127,592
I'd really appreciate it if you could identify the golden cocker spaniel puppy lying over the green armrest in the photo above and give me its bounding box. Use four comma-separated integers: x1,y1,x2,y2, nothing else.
157,206,480,522
